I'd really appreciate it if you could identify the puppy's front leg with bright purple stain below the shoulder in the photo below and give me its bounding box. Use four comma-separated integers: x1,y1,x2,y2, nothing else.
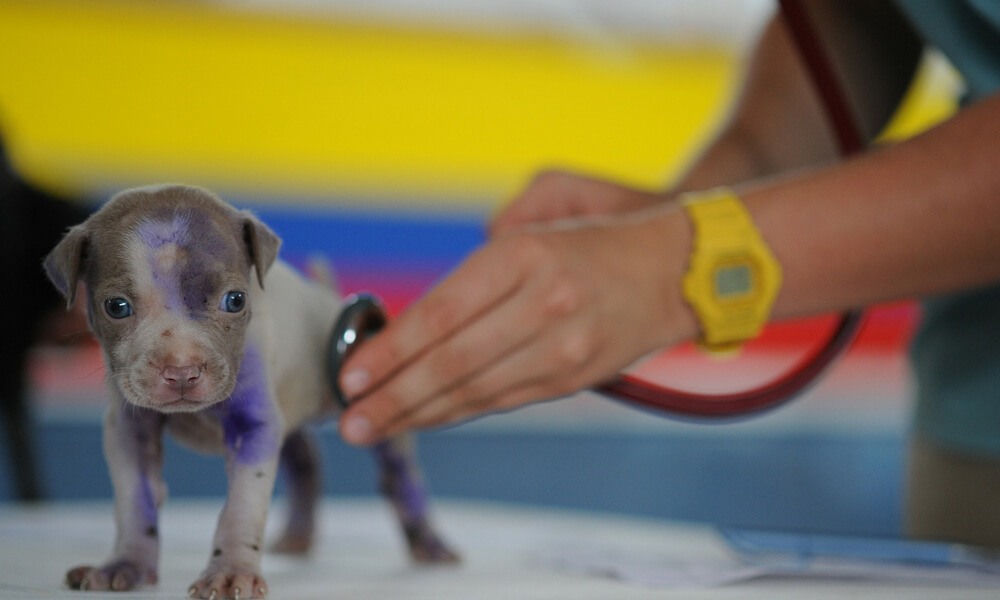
188,350,283,600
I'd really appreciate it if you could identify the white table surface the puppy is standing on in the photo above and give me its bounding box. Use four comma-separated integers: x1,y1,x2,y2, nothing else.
0,500,1000,600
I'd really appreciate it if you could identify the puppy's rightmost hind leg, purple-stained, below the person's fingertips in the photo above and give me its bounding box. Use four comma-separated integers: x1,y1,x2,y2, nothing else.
374,435,459,563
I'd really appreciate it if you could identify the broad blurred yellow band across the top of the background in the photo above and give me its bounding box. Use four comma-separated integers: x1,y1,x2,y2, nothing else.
0,0,951,207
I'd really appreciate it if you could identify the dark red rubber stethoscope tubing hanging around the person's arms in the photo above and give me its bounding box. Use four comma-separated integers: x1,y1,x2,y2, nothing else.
596,0,864,419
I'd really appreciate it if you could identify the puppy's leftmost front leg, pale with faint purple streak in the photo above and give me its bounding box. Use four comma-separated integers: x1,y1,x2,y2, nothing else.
66,398,167,591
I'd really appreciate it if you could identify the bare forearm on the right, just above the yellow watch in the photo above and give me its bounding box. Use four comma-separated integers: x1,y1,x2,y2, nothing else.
738,96,1000,318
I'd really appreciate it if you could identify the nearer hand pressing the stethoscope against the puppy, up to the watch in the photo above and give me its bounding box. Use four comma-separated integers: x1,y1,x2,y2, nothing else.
340,208,696,444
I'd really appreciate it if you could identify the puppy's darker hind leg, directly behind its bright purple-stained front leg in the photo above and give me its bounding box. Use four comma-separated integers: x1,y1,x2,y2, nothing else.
271,428,322,554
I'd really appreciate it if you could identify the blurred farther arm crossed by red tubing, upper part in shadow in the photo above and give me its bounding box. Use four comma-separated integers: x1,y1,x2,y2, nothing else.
674,0,922,191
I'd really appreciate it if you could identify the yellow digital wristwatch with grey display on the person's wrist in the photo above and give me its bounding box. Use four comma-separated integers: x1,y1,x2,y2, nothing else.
681,188,781,352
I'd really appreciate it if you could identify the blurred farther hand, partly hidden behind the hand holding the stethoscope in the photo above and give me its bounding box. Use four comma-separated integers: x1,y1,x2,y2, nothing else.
490,170,669,237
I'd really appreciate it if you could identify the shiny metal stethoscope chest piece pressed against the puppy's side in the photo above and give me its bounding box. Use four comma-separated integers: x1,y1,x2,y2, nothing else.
326,294,389,409
